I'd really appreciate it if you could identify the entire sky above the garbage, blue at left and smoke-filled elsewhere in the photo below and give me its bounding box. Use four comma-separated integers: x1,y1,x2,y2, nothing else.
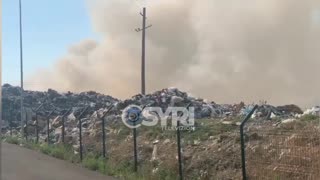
2,0,320,106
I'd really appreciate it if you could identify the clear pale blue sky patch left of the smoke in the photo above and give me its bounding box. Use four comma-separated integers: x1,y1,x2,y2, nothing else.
2,0,97,85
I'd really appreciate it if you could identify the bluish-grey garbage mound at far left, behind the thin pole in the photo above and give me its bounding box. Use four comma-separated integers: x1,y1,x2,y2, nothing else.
2,84,119,132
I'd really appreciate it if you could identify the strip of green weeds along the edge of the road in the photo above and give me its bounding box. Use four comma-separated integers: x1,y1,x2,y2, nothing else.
2,136,176,180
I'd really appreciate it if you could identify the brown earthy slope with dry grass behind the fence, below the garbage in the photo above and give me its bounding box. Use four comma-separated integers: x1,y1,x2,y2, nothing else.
6,118,320,180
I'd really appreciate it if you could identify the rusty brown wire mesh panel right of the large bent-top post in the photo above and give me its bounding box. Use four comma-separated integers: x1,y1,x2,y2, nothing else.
245,121,320,180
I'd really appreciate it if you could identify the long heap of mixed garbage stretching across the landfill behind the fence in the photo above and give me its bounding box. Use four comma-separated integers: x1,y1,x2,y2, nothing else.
2,84,320,143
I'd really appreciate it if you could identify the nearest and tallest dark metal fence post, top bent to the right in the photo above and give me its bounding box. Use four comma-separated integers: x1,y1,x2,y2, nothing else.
240,105,258,180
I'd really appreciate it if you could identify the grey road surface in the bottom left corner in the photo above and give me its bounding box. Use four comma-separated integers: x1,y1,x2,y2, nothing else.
0,143,114,180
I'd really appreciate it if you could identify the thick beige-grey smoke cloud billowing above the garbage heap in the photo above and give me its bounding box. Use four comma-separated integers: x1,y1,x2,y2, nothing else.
29,0,320,106
